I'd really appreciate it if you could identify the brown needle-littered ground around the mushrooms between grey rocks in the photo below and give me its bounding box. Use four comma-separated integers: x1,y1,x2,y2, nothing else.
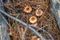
3,0,60,40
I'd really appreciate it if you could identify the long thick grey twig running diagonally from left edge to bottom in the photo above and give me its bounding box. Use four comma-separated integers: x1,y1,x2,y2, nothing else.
0,9,45,40
